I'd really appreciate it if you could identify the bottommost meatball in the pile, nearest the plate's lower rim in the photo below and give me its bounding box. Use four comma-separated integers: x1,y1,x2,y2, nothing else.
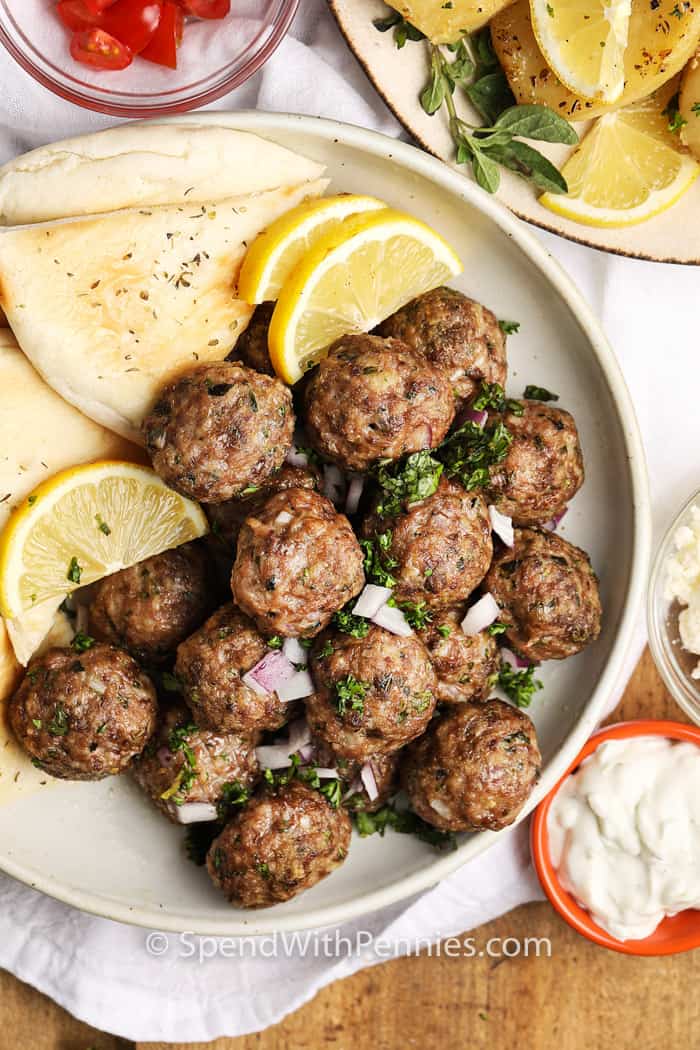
207,780,351,908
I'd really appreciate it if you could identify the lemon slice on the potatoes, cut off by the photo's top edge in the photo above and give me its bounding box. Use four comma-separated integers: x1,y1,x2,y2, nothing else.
530,0,632,102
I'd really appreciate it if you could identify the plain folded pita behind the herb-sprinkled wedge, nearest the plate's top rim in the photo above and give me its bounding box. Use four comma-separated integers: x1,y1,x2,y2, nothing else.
0,123,323,226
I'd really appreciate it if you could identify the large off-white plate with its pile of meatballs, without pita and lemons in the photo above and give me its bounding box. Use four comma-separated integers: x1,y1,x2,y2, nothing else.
0,114,649,933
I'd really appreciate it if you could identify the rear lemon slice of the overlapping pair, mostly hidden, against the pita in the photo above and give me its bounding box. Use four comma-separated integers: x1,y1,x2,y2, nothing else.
238,193,386,303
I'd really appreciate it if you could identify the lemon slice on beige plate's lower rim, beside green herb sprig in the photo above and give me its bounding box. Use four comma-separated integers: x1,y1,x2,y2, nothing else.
539,89,700,227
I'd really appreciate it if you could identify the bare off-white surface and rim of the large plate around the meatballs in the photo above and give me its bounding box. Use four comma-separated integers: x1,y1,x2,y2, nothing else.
0,113,650,935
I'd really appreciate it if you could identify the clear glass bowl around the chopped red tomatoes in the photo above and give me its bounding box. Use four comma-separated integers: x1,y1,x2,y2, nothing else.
0,0,299,119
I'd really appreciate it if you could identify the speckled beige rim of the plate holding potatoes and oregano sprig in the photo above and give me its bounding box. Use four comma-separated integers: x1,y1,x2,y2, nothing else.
327,0,700,266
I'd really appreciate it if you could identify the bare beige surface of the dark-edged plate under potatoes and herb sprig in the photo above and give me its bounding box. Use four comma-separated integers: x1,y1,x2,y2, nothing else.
328,0,700,266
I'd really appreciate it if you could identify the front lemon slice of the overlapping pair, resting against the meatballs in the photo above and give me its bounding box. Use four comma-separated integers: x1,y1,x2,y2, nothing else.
268,208,463,383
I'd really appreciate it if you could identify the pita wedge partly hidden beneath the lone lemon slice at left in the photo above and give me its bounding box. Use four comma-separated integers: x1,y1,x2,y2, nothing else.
0,330,144,804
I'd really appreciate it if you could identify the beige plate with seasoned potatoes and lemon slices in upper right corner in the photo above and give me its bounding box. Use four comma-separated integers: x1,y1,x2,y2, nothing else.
330,0,700,265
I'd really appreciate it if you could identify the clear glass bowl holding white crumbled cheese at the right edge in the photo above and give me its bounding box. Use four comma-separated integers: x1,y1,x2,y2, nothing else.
646,492,700,726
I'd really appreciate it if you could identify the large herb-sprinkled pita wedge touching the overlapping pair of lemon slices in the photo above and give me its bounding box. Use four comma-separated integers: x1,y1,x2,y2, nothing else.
0,181,326,442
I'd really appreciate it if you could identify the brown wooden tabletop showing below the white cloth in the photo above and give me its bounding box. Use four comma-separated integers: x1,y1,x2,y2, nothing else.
0,653,700,1050
